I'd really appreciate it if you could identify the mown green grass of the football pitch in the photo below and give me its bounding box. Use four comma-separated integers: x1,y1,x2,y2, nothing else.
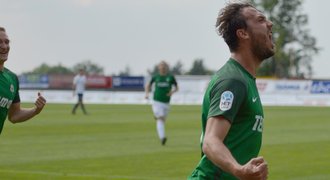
0,104,330,180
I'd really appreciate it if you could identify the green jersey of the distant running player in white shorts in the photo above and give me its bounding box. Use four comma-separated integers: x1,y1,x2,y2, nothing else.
150,74,177,103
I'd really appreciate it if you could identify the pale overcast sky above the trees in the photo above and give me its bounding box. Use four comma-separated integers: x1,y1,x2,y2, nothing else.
0,0,330,79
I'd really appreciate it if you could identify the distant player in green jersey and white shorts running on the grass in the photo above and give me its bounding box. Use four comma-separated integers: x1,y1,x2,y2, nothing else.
145,61,178,145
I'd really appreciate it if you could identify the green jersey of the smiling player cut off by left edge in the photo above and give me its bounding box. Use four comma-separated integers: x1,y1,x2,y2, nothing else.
0,68,20,134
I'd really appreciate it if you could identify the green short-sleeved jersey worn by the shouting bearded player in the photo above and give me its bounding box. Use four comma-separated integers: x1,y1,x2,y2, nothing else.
189,59,264,180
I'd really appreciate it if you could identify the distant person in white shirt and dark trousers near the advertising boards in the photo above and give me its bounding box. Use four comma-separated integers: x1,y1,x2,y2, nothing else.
72,69,87,115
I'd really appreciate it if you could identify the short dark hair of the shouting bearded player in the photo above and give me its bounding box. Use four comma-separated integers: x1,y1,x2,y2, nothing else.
215,2,254,52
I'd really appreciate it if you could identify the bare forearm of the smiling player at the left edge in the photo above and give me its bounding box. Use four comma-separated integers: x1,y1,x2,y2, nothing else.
8,107,40,123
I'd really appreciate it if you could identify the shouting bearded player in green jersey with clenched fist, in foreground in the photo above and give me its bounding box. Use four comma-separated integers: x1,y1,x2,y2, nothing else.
189,3,275,180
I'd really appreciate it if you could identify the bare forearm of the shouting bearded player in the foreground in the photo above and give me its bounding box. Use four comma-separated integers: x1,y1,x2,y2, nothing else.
203,138,242,176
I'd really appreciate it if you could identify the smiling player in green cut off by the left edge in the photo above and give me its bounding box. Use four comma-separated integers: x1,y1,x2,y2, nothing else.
0,27,46,133
